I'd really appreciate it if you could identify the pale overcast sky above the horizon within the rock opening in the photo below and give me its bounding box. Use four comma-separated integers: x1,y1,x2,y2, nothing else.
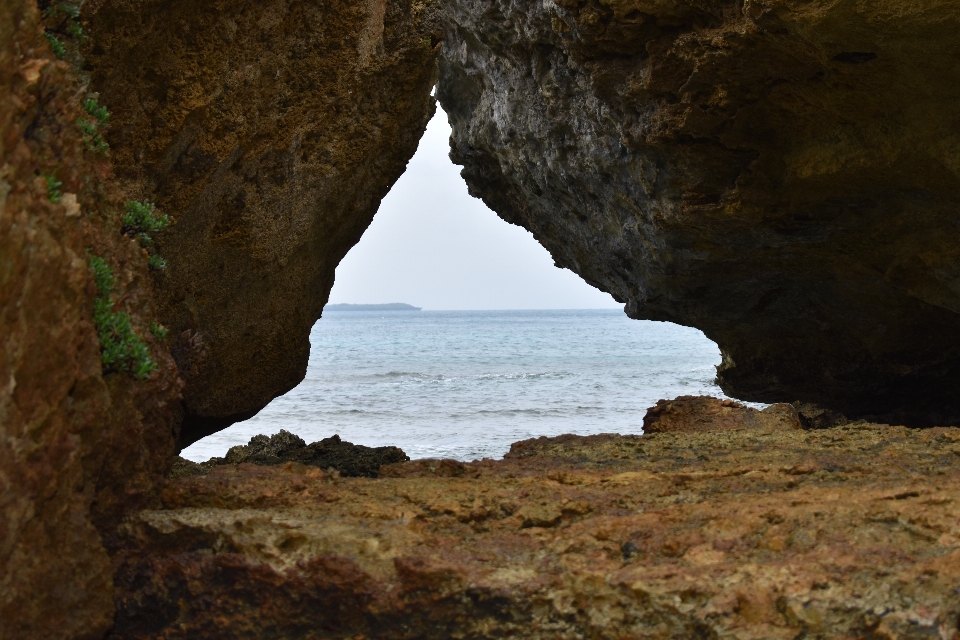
330,107,622,310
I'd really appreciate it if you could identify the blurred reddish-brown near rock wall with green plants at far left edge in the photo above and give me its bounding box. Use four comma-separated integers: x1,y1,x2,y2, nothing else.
0,0,179,640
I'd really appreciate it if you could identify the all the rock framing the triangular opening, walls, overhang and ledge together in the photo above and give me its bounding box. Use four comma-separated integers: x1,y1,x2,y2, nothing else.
0,0,960,640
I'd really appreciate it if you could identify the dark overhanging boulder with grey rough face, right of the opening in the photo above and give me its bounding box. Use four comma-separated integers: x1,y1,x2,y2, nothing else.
438,0,960,425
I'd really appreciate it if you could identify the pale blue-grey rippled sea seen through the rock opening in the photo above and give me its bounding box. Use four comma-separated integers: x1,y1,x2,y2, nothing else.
182,310,740,461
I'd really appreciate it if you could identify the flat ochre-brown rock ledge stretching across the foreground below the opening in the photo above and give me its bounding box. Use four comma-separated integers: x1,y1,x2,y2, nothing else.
107,398,960,639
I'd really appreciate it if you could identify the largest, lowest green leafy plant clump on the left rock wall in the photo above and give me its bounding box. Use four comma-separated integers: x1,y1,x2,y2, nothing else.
89,255,157,380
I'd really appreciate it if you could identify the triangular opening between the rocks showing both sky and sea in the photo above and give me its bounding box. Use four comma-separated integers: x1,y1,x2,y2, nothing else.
181,107,725,462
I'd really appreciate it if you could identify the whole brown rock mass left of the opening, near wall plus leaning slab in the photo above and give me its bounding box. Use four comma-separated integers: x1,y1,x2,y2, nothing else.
0,0,437,640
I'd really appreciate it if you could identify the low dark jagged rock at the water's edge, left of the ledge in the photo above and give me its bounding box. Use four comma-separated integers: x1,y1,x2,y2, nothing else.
172,429,410,478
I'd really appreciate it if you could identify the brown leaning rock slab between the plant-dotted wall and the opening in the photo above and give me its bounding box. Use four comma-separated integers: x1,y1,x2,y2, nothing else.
84,0,439,446
